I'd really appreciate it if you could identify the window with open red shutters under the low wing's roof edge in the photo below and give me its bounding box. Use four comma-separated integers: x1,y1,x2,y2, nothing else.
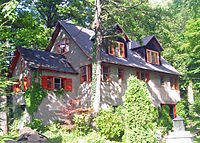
41,76,72,91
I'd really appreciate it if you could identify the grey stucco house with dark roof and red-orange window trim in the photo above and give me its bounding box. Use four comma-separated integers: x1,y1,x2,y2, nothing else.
9,21,181,121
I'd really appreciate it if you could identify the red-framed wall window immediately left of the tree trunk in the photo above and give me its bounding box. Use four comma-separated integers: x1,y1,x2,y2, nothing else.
80,65,92,83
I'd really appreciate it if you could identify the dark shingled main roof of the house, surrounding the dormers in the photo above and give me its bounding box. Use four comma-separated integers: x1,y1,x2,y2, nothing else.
52,21,181,75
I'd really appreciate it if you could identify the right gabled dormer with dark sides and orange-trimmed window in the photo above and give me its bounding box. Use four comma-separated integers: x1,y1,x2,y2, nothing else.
128,36,164,65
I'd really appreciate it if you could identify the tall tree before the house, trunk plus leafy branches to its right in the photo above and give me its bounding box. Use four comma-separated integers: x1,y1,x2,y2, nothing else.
91,0,169,111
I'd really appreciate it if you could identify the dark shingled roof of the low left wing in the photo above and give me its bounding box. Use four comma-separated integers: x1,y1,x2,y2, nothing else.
17,48,77,73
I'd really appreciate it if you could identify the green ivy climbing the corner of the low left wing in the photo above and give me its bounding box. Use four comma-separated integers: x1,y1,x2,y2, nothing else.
24,81,47,116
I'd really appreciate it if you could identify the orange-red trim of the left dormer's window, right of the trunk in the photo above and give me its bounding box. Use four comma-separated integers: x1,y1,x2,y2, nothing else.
108,40,125,58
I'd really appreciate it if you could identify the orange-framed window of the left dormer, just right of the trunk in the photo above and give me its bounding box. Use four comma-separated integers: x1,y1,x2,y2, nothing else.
108,40,125,57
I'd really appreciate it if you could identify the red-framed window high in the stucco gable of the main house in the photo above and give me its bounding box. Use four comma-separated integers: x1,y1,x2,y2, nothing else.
56,39,69,54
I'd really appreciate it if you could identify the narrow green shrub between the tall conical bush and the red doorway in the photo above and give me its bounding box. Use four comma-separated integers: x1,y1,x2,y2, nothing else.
158,105,173,136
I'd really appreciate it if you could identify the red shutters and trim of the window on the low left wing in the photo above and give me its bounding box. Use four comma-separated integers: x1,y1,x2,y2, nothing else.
41,76,72,91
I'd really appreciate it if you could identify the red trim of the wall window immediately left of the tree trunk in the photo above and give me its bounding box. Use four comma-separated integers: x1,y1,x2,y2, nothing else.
80,64,92,83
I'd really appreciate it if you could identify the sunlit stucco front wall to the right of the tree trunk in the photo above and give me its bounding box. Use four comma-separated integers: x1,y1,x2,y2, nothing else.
101,65,180,108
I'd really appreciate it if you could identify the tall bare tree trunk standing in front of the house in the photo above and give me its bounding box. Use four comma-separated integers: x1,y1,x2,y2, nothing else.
93,0,102,112
